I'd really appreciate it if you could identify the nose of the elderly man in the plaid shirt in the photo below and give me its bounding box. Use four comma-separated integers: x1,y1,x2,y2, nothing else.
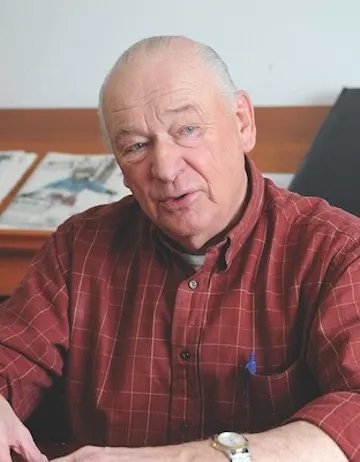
151,139,183,183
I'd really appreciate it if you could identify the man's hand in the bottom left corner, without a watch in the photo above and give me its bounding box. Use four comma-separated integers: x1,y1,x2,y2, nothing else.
0,396,48,462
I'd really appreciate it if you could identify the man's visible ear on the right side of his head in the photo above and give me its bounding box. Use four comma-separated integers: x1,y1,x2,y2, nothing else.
235,90,256,153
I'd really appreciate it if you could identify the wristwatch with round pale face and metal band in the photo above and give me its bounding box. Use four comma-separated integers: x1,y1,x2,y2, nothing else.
211,432,251,462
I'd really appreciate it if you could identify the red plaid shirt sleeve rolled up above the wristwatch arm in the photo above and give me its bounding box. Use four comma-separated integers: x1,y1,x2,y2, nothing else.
287,244,360,461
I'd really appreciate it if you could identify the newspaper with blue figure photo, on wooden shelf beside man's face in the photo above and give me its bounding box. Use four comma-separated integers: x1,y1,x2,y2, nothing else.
0,152,131,231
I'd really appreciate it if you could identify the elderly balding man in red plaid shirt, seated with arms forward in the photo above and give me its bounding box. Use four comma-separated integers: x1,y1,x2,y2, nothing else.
0,37,360,462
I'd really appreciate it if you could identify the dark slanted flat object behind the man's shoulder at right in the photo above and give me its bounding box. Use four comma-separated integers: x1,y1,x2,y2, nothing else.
289,88,360,217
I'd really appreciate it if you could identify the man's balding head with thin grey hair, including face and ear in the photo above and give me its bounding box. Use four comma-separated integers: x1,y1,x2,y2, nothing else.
99,37,256,252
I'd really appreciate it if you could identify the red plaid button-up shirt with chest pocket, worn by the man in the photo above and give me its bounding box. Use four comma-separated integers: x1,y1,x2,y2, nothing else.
0,160,360,460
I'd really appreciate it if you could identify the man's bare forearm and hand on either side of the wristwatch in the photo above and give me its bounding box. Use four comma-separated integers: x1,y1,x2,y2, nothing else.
44,422,346,462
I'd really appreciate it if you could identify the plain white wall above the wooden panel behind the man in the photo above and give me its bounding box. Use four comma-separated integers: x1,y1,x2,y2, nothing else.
0,0,360,108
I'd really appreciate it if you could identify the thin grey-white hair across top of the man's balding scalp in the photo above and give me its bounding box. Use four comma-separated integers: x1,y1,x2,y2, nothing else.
99,36,236,147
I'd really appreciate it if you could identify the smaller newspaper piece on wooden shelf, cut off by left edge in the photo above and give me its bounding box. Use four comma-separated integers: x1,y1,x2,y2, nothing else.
0,151,38,203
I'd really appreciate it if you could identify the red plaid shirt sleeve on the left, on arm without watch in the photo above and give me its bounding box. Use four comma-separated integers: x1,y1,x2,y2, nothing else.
0,224,70,419
